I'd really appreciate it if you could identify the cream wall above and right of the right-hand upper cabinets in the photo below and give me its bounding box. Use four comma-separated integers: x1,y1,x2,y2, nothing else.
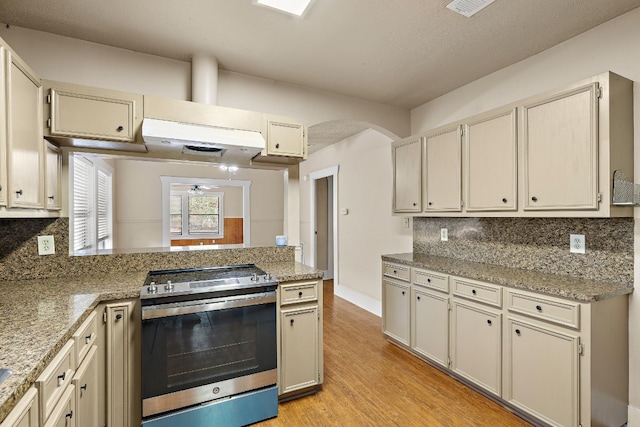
411,9,640,427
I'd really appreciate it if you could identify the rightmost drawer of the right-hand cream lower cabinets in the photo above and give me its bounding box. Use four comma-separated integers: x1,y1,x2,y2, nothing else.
507,290,580,329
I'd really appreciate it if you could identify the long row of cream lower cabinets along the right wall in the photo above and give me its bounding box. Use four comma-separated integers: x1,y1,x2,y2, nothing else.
382,261,629,427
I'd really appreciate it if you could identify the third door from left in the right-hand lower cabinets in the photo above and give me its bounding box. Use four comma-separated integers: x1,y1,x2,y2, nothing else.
451,299,502,396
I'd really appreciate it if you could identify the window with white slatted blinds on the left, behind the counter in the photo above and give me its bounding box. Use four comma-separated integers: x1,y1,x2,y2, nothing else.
70,155,113,252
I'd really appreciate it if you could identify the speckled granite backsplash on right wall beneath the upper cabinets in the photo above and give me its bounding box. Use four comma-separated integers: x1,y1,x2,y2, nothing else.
413,218,634,284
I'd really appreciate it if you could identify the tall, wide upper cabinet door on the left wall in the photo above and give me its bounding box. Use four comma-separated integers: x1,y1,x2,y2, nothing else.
5,51,44,208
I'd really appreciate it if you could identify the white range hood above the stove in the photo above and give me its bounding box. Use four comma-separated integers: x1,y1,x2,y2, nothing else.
142,117,266,159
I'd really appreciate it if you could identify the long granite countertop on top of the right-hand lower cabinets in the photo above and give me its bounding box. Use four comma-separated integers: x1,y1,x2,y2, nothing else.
382,253,633,303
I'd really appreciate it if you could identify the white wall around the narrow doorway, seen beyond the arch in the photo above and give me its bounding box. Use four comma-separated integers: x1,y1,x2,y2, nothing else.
300,130,413,315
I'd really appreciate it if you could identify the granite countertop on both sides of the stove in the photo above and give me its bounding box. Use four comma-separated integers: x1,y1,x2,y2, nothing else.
0,261,322,422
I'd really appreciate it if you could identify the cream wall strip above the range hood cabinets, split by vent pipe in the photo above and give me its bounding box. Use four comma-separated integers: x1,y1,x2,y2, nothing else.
0,25,410,136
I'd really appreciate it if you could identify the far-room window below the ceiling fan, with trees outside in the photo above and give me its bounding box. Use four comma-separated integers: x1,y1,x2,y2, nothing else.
169,184,224,239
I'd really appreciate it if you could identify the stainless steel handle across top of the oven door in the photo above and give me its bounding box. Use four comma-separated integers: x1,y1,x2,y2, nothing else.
142,292,276,320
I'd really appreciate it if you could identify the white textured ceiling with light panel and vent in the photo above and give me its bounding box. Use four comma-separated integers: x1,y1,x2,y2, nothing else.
0,0,640,112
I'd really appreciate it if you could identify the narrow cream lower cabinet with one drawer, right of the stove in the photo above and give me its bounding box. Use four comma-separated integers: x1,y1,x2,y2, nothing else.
277,280,324,398
